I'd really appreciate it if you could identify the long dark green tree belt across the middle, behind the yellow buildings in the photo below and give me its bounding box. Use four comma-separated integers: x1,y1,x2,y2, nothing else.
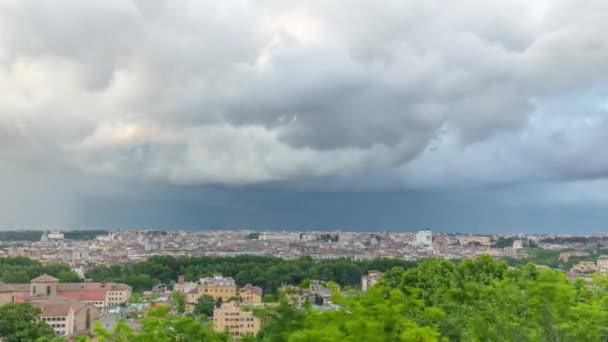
87,255,415,293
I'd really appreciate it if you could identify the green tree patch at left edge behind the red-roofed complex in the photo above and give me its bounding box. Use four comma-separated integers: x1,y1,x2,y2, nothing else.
0,257,82,283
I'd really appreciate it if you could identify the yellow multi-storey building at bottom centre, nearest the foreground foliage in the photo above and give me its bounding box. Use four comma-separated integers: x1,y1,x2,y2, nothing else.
213,302,262,338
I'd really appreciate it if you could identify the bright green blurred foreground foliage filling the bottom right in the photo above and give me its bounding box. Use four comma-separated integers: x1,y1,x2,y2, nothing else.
253,257,608,342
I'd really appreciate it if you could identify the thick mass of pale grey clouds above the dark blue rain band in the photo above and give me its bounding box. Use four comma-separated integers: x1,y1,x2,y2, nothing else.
0,0,608,190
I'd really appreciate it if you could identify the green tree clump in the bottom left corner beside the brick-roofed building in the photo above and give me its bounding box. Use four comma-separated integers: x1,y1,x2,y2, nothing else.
0,304,55,342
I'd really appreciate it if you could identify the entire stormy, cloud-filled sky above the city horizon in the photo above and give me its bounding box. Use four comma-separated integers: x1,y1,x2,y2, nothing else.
0,0,608,233
